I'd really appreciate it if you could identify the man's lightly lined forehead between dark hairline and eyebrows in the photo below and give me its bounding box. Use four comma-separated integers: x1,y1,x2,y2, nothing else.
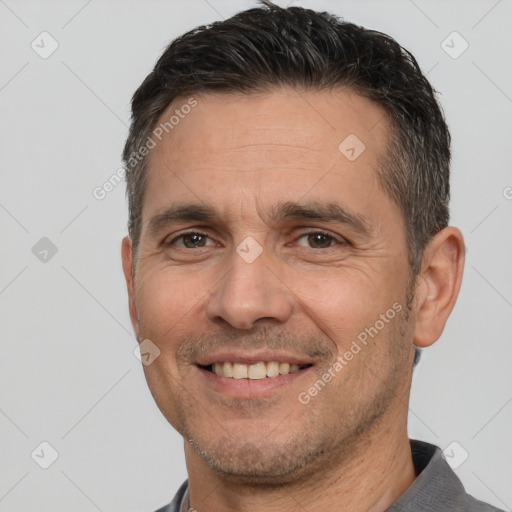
143,88,387,223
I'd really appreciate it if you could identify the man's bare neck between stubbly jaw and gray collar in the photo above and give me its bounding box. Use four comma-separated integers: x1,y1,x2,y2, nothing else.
185,425,415,512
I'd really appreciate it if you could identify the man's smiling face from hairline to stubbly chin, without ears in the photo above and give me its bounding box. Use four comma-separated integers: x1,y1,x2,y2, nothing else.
123,89,414,483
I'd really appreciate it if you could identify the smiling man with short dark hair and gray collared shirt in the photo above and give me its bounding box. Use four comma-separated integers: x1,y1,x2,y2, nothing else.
122,1,497,512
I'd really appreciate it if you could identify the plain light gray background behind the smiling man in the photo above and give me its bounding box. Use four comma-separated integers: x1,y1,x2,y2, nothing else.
0,0,512,512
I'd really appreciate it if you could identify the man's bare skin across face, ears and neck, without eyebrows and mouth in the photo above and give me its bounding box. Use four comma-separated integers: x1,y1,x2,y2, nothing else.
122,88,464,512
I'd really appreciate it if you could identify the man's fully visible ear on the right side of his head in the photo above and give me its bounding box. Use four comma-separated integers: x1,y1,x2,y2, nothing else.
414,226,465,347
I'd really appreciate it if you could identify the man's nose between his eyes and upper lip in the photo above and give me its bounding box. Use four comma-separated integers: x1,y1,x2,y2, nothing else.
206,242,293,330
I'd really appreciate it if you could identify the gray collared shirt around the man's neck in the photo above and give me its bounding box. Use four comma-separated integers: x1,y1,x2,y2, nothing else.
156,440,503,512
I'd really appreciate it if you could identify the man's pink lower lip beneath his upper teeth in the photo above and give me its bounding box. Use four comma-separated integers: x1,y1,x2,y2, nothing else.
197,366,313,398
